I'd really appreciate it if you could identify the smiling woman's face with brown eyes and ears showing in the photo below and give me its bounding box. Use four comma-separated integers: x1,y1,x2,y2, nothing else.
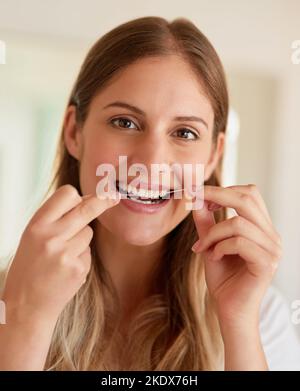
65,55,223,245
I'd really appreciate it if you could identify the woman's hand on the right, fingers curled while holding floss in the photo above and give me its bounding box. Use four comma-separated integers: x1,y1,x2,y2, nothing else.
193,185,282,326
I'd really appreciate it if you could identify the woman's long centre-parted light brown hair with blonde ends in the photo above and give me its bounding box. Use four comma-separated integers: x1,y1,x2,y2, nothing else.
45,17,228,370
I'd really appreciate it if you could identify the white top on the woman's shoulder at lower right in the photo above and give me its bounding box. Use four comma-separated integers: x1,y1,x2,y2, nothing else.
260,286,300,370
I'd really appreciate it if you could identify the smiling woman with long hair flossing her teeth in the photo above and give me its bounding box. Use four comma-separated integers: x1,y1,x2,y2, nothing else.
0,17,299,370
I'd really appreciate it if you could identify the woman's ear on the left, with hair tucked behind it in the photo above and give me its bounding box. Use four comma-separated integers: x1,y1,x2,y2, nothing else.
63,105,82,160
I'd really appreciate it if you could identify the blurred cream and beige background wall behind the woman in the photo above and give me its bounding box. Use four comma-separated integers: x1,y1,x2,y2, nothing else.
0,0,300,329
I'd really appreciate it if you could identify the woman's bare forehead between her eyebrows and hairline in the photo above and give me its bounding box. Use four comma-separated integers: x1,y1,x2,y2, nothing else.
91,55,213,122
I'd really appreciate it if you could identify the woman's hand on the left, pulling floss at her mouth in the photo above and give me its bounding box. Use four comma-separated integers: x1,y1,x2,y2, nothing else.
2,185,120,322
